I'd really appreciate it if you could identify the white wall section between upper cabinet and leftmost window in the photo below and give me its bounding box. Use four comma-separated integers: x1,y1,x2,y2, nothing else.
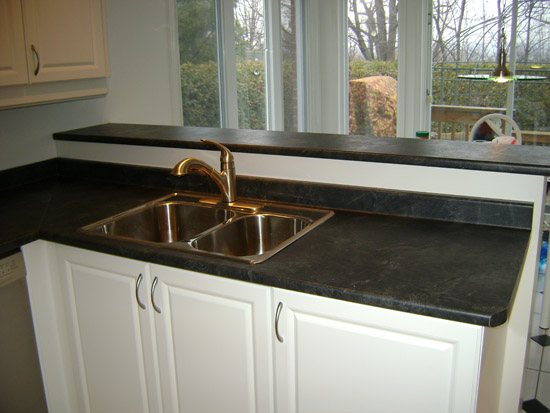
105,0,182,125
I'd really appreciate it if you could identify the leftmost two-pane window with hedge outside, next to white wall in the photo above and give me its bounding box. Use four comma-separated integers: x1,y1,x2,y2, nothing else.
176,0,276,129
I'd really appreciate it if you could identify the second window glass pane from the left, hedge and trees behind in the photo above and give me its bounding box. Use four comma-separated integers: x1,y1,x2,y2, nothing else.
234,0,266,129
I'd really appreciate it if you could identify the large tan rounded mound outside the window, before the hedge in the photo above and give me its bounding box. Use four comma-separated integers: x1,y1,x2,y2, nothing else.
349,76,397,137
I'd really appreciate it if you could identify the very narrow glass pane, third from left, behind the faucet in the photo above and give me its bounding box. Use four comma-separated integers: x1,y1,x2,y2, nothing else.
281,0,298,131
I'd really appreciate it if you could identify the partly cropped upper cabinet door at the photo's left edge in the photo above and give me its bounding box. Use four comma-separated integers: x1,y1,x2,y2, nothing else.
0,0,28,86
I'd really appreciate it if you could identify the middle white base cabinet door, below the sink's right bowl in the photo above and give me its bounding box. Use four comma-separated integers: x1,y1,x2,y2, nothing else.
151,265,273,413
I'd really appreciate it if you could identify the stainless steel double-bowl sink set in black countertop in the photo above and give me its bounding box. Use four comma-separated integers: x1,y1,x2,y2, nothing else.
82,193,334,264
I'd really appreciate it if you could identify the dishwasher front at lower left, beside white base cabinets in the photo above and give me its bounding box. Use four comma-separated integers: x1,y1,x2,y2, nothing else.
0,251,48,413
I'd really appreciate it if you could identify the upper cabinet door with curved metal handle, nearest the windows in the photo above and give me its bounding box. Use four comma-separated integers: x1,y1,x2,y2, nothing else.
23,0,107,83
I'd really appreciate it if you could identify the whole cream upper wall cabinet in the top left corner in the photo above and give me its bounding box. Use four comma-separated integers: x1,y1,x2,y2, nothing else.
0,0,108,107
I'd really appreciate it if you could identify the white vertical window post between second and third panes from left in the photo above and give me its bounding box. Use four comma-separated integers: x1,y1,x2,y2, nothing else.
264,0,284,131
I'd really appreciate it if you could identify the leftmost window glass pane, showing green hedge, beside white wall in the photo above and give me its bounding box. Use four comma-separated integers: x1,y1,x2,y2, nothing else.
176,0,220,127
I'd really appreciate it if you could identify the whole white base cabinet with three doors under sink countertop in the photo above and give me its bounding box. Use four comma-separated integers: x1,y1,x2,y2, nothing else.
23,241,488,413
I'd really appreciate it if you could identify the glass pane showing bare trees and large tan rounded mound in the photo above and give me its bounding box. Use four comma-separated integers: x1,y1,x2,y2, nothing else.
348,0,398,136
